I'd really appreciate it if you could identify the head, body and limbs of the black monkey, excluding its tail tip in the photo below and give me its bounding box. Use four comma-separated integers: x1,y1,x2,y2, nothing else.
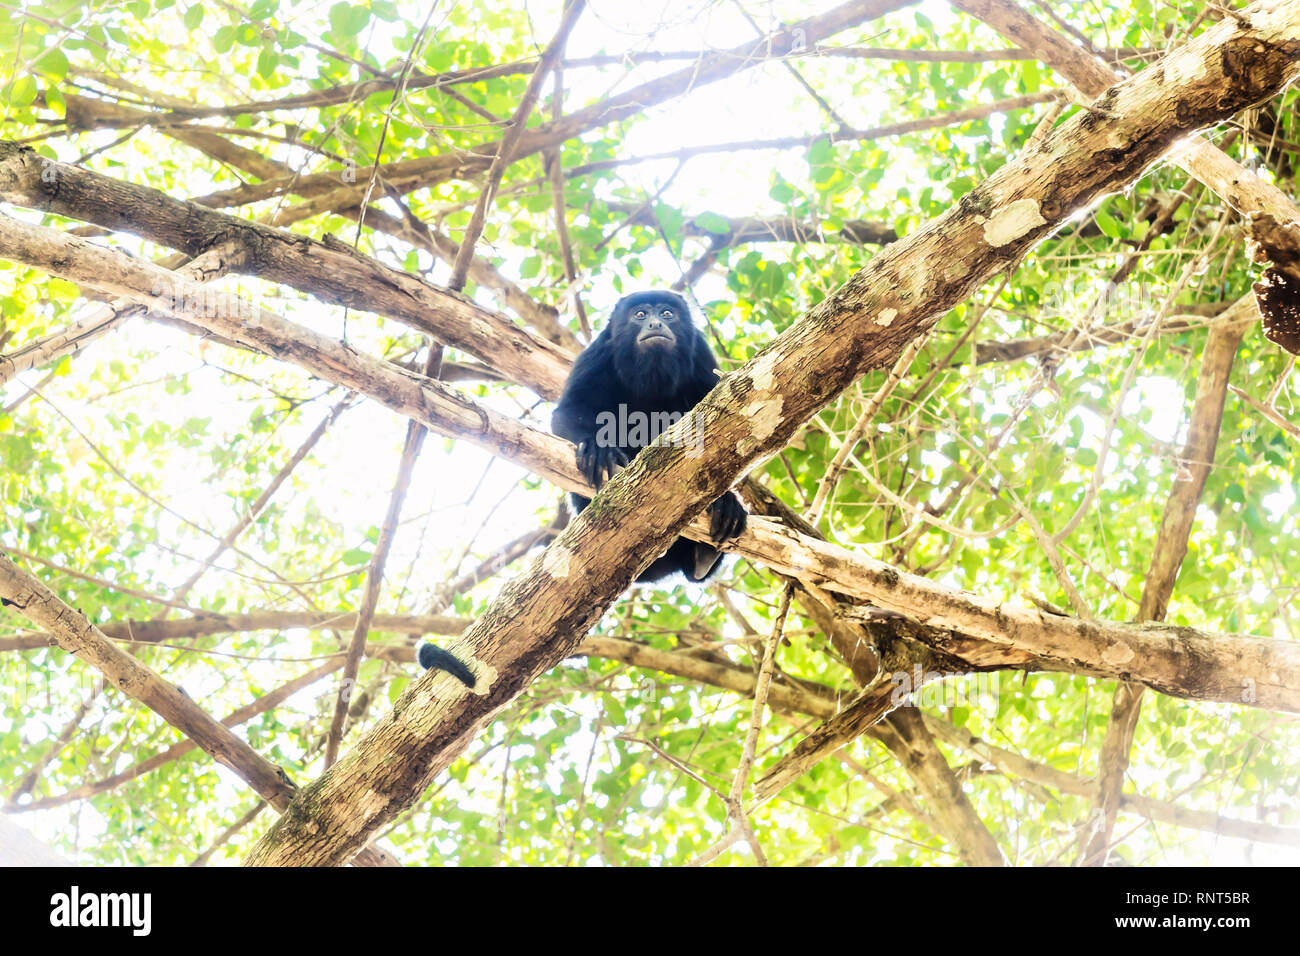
551,291,749,581
